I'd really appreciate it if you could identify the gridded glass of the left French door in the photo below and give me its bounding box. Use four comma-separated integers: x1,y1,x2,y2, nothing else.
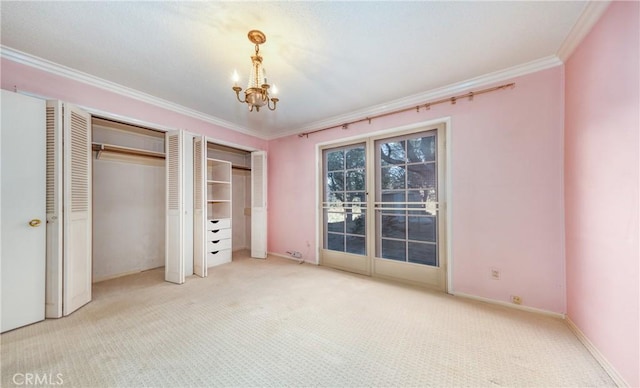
323,144,367,255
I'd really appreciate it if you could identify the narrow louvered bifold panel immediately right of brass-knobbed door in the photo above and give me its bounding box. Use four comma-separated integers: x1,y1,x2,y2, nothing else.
45,101,63,318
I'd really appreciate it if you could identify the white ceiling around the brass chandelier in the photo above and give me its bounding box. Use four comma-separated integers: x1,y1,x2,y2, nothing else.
0,1,587,139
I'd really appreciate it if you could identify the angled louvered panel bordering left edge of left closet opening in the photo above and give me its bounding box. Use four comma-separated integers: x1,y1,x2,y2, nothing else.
62,104,92,315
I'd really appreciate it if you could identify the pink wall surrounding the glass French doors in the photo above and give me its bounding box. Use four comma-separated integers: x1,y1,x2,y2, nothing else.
269,67,565,313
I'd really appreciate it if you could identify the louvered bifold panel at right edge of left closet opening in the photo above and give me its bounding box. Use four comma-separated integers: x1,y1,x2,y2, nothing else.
164,131,184,284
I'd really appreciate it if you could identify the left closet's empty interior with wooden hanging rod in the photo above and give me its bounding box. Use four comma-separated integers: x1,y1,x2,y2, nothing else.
92,117,166,283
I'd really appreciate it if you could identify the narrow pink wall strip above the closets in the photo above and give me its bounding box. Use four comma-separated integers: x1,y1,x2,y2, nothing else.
0,58,267,149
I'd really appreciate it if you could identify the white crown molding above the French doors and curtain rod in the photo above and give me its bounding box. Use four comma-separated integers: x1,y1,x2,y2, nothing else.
268,55,562,140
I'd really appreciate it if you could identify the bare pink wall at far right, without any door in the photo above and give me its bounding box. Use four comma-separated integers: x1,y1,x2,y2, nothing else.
565,2,640,387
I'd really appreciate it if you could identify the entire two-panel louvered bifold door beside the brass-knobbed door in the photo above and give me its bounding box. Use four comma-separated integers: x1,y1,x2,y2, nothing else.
46,101,92,318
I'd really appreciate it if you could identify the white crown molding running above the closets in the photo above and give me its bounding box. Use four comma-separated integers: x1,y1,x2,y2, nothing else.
0,45,267,140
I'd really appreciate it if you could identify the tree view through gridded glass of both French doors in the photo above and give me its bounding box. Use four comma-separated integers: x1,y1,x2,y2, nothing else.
323,131,438,266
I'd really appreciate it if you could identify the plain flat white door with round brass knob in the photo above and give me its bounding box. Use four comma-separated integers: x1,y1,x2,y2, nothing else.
0,90,46,332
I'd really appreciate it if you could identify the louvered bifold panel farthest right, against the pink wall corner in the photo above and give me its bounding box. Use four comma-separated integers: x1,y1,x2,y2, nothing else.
251,151,267,259
